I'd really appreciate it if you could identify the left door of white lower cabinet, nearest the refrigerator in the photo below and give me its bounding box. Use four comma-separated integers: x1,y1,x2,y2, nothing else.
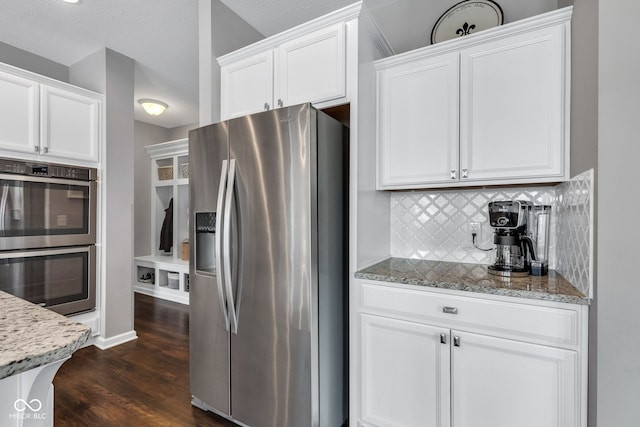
360,314,450,427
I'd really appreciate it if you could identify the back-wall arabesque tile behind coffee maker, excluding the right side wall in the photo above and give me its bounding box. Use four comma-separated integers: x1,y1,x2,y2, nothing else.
391,187,556,269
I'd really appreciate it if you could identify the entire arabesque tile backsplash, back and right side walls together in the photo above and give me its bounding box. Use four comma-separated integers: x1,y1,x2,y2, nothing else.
390,171,593,294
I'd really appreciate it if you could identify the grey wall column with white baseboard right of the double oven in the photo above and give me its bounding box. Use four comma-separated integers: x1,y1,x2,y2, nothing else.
69,49,136,348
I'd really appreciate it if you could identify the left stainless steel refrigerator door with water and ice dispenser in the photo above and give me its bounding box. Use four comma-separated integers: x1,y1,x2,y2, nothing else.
189,123,230,415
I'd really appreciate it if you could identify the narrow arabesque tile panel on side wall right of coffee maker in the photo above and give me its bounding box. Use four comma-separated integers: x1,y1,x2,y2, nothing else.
556,169,593,298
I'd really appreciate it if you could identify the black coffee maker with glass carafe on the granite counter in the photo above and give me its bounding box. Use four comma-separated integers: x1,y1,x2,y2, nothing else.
488,200,551,277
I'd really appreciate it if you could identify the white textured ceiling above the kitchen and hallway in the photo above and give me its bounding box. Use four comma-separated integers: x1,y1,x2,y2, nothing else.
0,0,558,128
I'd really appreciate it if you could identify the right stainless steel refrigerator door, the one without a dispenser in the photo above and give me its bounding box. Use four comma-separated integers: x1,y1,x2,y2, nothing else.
229,105,317,427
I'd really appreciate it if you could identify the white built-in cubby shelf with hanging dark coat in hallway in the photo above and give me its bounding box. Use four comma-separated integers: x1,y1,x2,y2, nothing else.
133,138,189,304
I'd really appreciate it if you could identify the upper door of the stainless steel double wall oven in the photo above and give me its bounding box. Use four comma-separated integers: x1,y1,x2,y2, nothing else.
0,174,96,250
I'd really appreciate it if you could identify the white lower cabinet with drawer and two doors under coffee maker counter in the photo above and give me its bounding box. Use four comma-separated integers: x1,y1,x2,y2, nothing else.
351,282,588,427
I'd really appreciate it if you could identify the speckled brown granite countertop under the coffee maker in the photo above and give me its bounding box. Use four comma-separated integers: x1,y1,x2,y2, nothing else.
355,258,589,305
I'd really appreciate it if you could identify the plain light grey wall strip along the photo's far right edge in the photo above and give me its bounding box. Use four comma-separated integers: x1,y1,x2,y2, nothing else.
594,0,640,427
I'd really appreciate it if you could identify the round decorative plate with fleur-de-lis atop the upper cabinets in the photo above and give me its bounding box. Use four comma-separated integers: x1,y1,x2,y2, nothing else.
431,0,504,44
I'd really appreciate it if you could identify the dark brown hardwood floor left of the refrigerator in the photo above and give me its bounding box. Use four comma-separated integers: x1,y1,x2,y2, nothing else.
53,294,234,427
